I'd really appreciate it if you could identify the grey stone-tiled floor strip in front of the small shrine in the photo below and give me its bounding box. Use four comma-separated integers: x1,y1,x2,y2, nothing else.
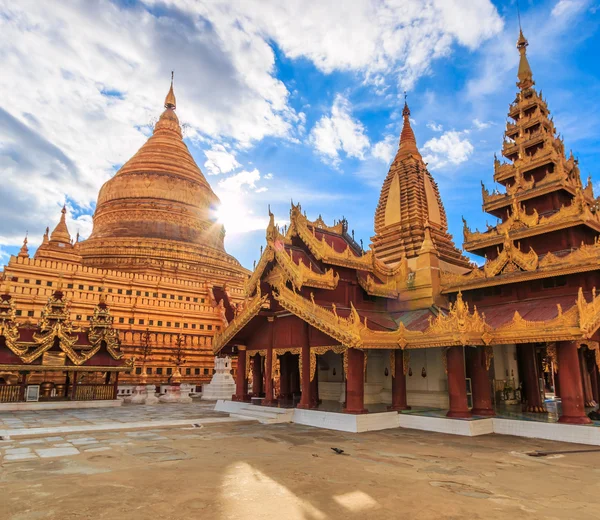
0,401,222,430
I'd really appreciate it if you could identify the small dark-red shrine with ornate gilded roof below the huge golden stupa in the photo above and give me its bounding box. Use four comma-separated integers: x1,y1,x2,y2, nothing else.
0,282,131,403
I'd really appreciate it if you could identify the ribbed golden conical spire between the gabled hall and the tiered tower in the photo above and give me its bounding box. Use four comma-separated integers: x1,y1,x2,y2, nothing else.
372,103,470,268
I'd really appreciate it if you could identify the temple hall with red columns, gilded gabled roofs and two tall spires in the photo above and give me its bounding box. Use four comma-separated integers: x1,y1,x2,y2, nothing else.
213,33,600,430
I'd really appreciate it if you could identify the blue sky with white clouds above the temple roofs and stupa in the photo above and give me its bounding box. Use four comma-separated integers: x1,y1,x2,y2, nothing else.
0,0,600,268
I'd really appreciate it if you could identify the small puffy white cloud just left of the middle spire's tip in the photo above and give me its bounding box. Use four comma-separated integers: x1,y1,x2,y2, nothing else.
309,94,369,166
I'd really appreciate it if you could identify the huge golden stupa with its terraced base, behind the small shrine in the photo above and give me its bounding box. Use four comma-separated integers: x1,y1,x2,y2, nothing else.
4,77,249,394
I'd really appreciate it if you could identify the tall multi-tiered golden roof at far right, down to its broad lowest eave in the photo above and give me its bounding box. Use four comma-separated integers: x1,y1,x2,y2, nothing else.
442,32,600,292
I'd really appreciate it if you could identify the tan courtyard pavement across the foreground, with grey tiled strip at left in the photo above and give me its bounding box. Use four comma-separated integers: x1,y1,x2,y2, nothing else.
0,403,600,520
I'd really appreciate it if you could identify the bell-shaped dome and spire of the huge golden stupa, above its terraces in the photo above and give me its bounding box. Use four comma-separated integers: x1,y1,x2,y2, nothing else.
78,73,240,280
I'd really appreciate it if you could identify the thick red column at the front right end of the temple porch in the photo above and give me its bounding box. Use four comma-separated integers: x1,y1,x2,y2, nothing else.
556,341,592,424
